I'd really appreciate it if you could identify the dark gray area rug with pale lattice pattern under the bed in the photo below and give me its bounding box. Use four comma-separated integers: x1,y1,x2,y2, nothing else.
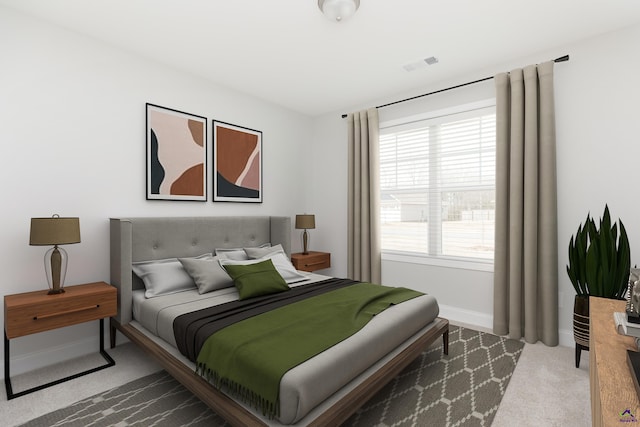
23,326,524,427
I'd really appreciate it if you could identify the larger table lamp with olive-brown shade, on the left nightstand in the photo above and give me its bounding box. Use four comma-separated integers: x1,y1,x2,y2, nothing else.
29,214,80,295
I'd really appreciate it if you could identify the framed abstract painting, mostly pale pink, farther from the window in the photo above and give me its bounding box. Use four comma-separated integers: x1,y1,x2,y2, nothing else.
147,103,207,201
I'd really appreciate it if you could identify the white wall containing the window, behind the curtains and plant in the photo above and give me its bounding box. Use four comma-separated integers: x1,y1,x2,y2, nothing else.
311,21,640,346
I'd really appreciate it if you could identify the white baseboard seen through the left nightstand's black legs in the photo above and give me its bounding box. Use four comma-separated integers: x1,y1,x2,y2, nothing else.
0,337,99,380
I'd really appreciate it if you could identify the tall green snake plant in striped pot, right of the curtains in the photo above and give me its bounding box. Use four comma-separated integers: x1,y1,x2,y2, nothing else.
567,205,631,368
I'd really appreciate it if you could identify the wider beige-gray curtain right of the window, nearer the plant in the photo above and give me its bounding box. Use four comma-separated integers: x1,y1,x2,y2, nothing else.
493,61,558,346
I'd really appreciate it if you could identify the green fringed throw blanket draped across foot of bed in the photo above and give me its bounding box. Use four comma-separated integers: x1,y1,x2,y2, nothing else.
197,283,423,418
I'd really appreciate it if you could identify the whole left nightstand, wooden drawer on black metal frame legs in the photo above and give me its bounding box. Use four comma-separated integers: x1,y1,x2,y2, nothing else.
4,282,118,399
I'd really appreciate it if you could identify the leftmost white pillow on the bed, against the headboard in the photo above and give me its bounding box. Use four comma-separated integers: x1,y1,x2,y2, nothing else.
132,253,213,298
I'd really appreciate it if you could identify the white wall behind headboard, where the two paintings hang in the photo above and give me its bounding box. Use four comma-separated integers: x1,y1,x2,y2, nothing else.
0,7,312,374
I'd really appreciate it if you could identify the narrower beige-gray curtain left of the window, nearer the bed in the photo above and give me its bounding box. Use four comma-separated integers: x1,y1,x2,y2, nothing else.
347,108,381,283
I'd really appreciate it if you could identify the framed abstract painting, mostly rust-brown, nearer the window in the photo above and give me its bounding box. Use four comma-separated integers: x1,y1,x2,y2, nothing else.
212,120,262,203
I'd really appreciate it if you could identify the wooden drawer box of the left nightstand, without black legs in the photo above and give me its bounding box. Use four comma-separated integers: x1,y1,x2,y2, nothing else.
5,284,117,339
